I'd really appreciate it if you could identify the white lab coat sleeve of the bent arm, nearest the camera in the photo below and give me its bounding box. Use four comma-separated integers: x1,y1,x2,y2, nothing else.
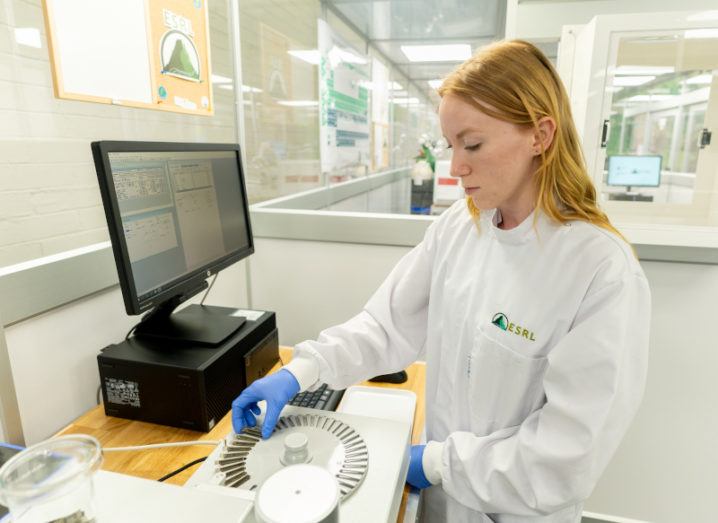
425,273,650,516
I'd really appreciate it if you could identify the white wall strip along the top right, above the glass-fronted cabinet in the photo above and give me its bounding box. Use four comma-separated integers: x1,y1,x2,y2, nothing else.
507,0,717,40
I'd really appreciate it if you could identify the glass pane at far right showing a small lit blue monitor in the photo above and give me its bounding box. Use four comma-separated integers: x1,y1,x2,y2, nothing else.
599,29,718,225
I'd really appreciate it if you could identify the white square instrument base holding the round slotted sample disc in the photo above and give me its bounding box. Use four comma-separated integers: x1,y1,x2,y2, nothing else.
186,405,412,523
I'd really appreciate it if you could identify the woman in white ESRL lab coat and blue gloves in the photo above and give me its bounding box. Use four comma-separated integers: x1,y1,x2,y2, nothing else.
233,41,650,523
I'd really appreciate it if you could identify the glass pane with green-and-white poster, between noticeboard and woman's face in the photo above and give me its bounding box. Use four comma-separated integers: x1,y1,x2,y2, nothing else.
239,0,440,212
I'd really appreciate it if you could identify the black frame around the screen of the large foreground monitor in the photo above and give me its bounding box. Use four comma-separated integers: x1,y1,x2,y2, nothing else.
91,140,254,314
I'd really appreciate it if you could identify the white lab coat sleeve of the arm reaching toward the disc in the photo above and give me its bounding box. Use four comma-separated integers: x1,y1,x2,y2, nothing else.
287,222,437,389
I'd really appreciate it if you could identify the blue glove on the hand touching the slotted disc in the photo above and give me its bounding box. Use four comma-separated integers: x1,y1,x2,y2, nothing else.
232,369,299,439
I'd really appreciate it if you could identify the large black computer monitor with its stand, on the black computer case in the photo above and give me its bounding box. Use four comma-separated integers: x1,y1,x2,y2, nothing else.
92,141,254,345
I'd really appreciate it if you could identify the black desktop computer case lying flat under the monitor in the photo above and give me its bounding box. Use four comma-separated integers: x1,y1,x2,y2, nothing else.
97,307,279,432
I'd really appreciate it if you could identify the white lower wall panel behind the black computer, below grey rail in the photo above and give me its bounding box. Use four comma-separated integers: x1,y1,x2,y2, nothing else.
5,262,248,445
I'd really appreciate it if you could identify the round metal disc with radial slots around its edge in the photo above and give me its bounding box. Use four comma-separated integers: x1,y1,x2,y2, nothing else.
215,414,369,499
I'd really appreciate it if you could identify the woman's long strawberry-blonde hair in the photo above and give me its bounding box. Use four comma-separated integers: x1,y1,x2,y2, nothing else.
439,40,625,244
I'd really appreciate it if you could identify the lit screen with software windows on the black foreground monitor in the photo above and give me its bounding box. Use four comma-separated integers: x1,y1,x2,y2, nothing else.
108,151,249,299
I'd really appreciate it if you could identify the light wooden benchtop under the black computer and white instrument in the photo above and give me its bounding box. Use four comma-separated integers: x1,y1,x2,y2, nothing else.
57,347,426,521
